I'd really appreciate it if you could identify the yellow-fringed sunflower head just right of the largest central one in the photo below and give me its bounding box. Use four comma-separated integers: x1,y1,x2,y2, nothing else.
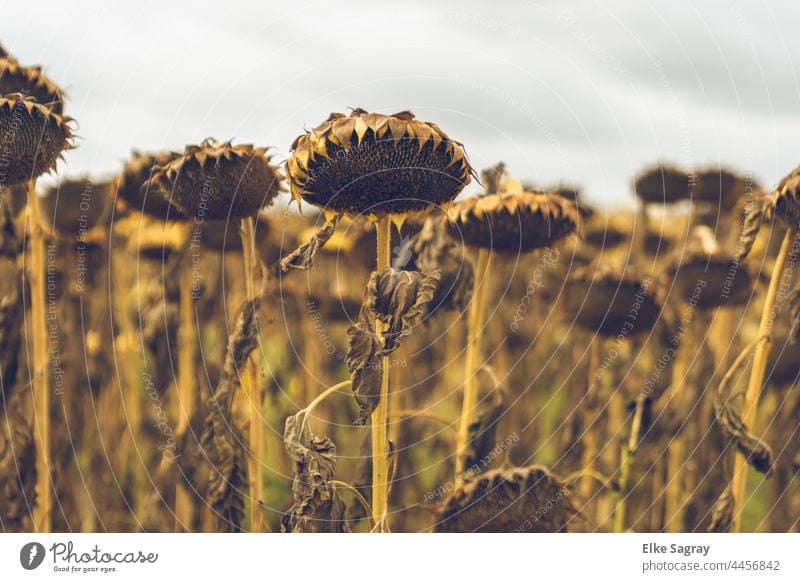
447,192,579,255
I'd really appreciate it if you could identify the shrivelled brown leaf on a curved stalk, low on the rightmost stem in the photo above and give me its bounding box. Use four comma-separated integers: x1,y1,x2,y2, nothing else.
714,351,773,476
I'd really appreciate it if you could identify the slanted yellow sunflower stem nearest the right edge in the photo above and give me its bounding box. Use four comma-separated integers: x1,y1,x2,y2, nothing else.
730,228,794,532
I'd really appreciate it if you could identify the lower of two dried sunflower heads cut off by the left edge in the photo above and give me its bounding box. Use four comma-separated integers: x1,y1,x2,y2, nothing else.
0,93,73,186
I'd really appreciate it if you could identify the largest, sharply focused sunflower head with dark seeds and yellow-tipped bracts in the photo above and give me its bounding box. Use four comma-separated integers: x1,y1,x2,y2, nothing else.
286,109,475,216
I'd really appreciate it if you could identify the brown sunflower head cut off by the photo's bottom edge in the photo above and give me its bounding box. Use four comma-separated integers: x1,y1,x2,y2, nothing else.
434,465,578,533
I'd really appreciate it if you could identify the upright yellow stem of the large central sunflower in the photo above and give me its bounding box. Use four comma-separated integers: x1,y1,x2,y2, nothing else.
372,215,392,532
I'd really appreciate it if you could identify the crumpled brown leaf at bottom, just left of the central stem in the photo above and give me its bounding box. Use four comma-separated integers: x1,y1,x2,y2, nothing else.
281,412,350,533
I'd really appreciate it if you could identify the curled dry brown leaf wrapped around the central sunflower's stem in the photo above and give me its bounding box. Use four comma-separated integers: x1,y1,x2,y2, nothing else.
345,267,441,425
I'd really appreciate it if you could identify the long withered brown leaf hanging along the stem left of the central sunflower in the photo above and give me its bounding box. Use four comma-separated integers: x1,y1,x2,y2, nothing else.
197,297,260,532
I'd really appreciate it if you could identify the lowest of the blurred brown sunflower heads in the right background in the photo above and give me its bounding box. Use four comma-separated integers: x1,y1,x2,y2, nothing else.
563,267,664,337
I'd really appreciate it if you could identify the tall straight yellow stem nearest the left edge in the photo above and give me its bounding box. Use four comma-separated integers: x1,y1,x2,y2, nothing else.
26,180,53,533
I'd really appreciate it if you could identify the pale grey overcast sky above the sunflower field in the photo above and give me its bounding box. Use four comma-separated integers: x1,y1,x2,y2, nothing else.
0,0,800,210
